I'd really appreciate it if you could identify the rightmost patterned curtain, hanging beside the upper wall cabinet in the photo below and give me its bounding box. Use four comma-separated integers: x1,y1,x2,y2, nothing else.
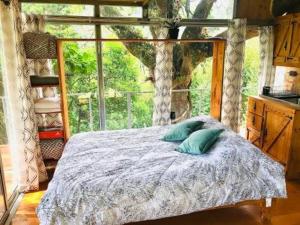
258,27,275,94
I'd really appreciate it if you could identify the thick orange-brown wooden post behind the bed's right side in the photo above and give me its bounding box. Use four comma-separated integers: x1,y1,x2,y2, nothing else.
210,41,226,121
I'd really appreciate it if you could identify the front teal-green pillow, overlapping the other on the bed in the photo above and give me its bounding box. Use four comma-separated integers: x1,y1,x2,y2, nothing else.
176,129,224,155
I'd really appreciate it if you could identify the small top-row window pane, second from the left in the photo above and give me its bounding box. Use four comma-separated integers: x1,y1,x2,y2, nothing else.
100,5,143,18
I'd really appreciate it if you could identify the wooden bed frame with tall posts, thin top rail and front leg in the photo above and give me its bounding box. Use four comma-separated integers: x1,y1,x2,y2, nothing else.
57,39,276,225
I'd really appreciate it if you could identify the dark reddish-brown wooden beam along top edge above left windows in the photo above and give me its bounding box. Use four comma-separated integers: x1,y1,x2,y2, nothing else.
20,0,149,6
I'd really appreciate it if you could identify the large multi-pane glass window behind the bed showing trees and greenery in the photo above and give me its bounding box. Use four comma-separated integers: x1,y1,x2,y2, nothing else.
22,0,227,134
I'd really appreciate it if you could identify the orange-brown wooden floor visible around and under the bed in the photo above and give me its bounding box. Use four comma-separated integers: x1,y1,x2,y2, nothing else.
11,181,300,225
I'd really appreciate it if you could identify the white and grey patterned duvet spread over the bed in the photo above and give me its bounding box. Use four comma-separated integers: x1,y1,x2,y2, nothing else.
37,116,286,225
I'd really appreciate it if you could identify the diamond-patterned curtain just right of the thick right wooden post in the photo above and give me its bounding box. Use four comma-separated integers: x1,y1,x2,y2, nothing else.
222,19,247,132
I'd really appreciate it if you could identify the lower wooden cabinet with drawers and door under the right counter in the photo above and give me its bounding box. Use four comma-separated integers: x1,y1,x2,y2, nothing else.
246,97,300,179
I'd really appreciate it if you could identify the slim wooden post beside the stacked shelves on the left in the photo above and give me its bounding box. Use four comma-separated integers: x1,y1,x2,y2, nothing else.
57,40,70,142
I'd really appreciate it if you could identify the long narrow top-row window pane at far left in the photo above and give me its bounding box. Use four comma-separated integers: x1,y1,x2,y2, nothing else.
22,3,94,16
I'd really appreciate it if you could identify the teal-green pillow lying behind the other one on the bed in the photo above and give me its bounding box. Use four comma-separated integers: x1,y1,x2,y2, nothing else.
162,121,204,142
